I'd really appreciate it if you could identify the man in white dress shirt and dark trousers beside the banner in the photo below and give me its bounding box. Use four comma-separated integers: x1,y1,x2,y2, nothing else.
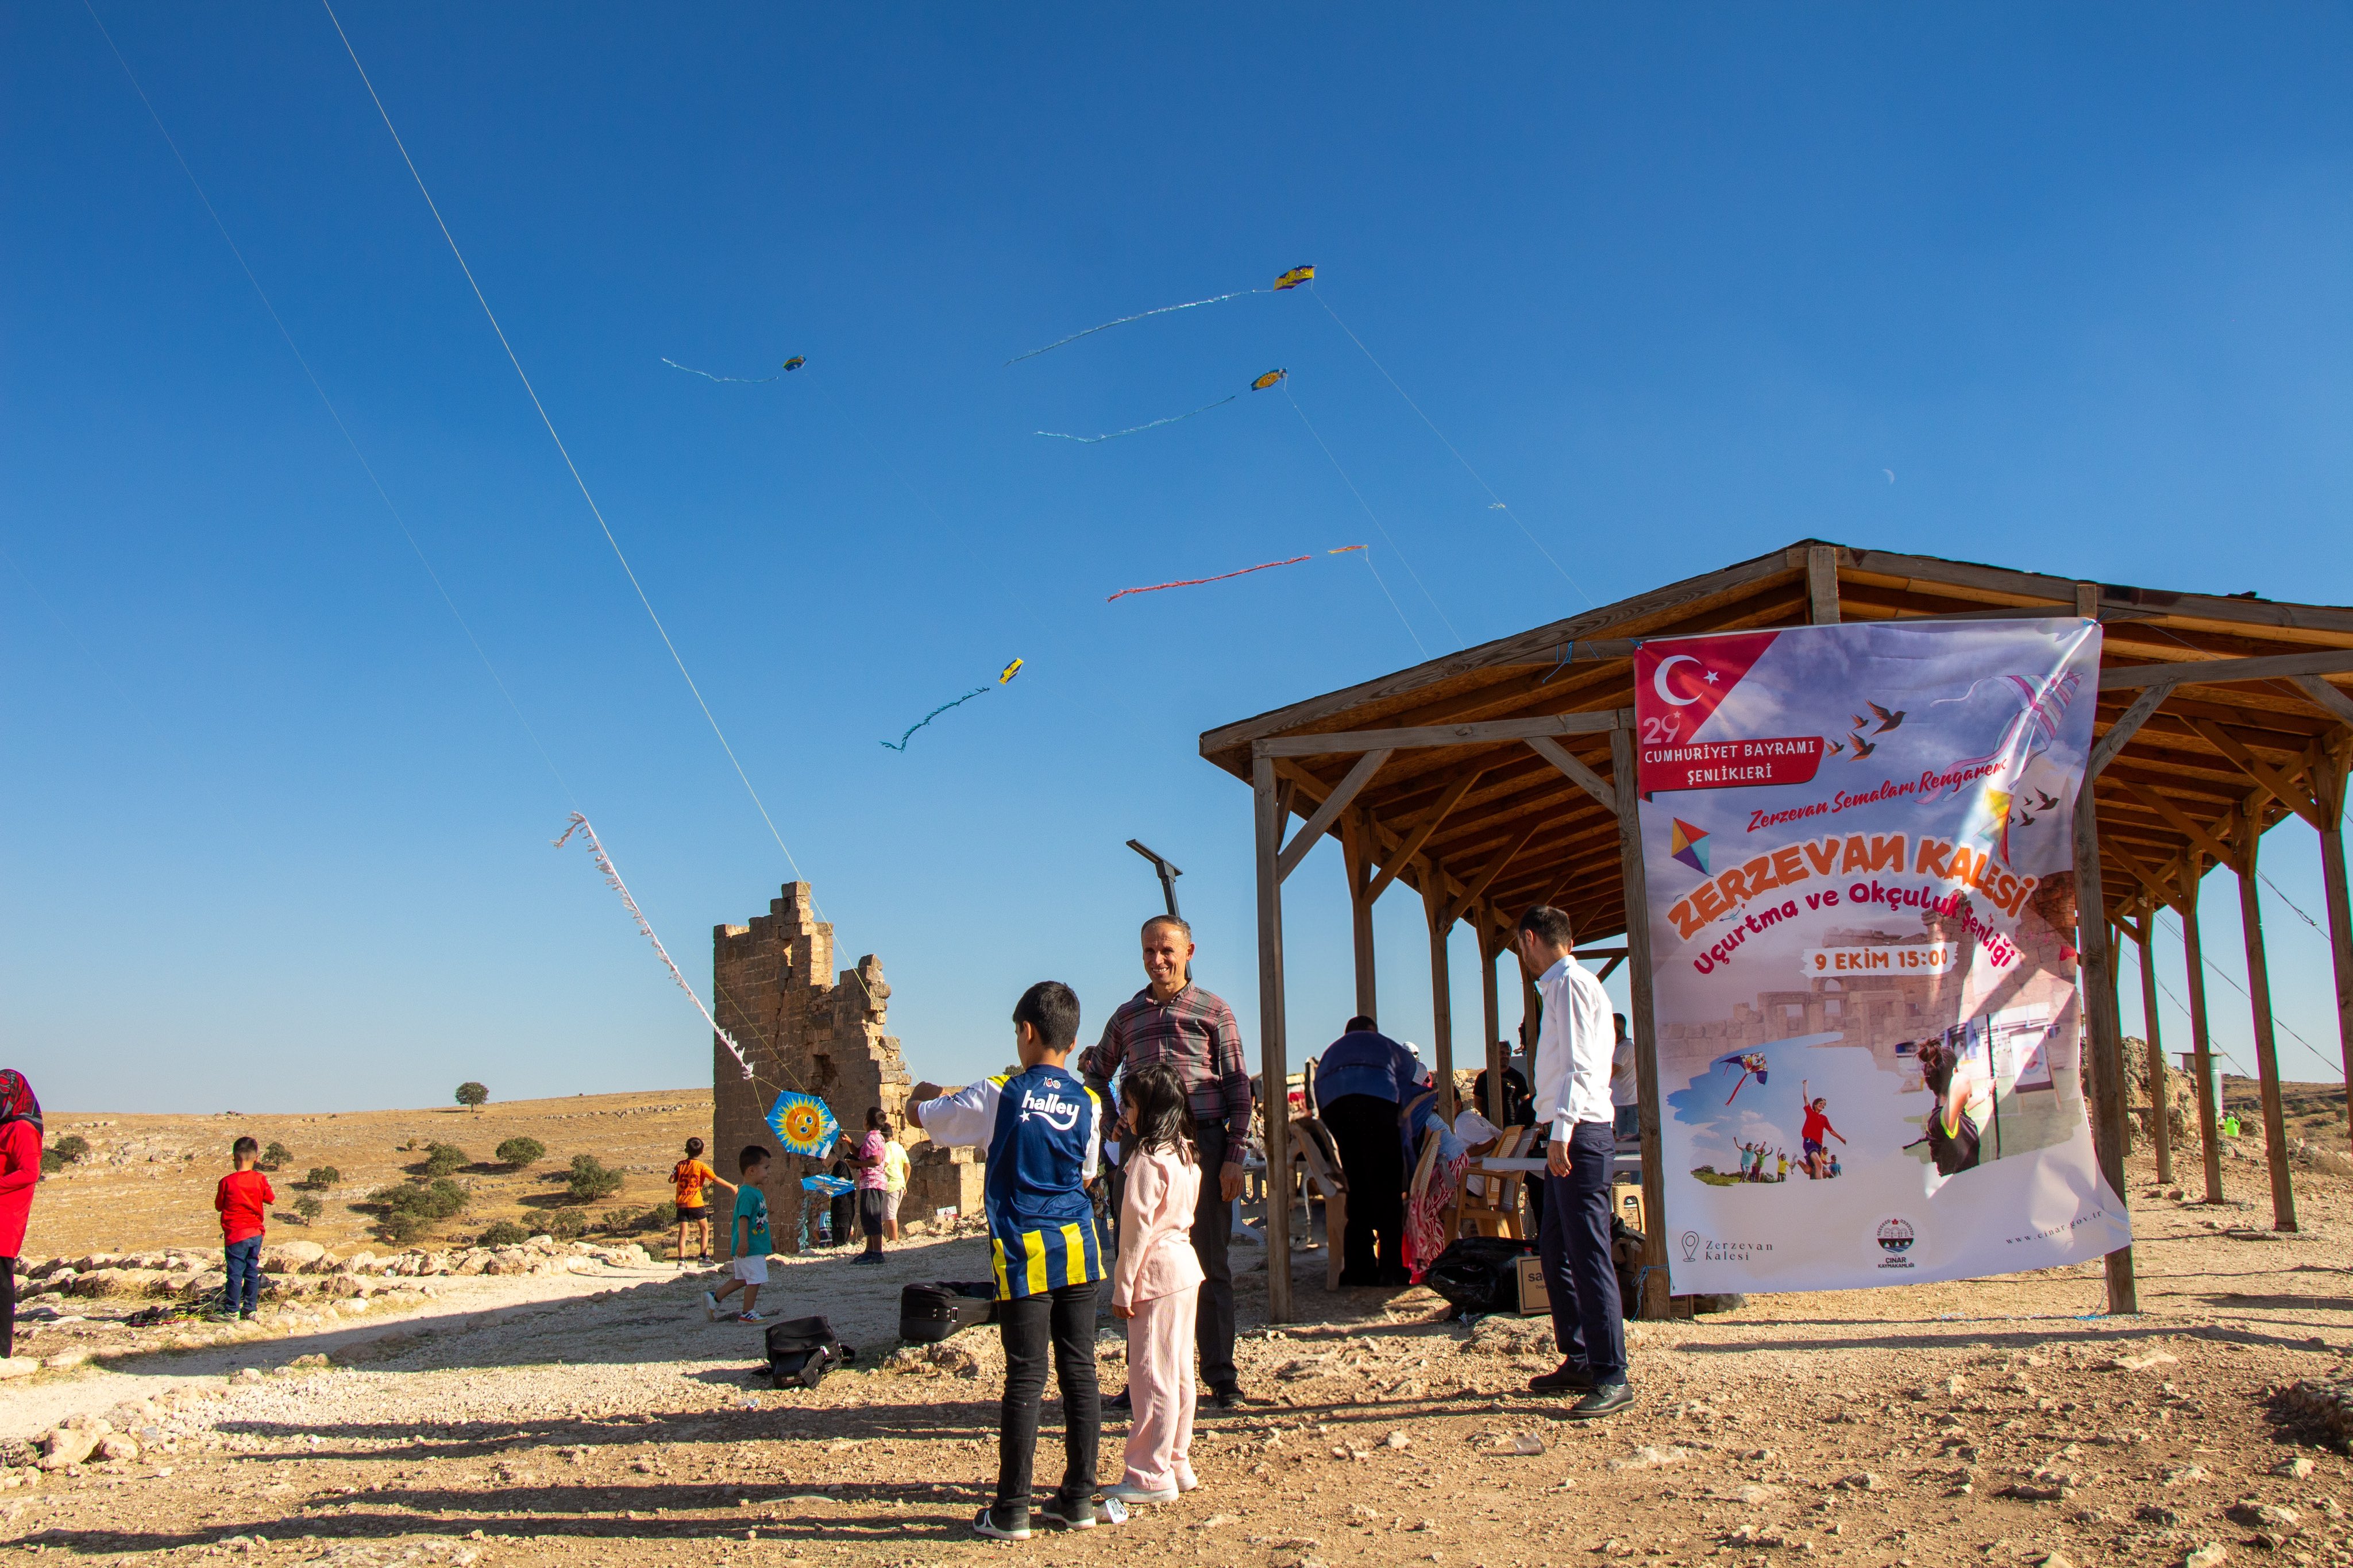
1515,905,1633,1420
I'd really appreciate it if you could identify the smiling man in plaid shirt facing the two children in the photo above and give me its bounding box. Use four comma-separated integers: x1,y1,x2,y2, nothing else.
1078,914,1252,1411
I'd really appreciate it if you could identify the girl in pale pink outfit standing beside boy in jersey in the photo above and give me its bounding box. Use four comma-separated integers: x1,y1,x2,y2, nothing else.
1104,1063,1202,1502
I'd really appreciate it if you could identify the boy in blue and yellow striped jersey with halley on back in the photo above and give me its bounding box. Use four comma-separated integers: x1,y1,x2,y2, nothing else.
908,980,1110,1540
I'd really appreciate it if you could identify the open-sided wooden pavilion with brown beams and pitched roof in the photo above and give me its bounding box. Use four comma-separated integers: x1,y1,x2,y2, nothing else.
1200,540,2353,1321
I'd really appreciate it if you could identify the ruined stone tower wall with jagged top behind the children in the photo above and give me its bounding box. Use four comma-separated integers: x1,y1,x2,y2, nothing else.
711,882,979,1253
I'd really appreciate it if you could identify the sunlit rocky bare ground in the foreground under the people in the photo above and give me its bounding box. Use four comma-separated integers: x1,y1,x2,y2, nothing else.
0,1114,2353,1568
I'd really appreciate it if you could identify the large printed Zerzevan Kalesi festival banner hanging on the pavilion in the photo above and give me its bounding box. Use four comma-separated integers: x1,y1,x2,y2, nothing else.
1635,621,2130,1293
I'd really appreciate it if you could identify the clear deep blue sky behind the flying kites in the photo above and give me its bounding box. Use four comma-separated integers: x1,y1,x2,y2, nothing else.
0,0,2353,1110
